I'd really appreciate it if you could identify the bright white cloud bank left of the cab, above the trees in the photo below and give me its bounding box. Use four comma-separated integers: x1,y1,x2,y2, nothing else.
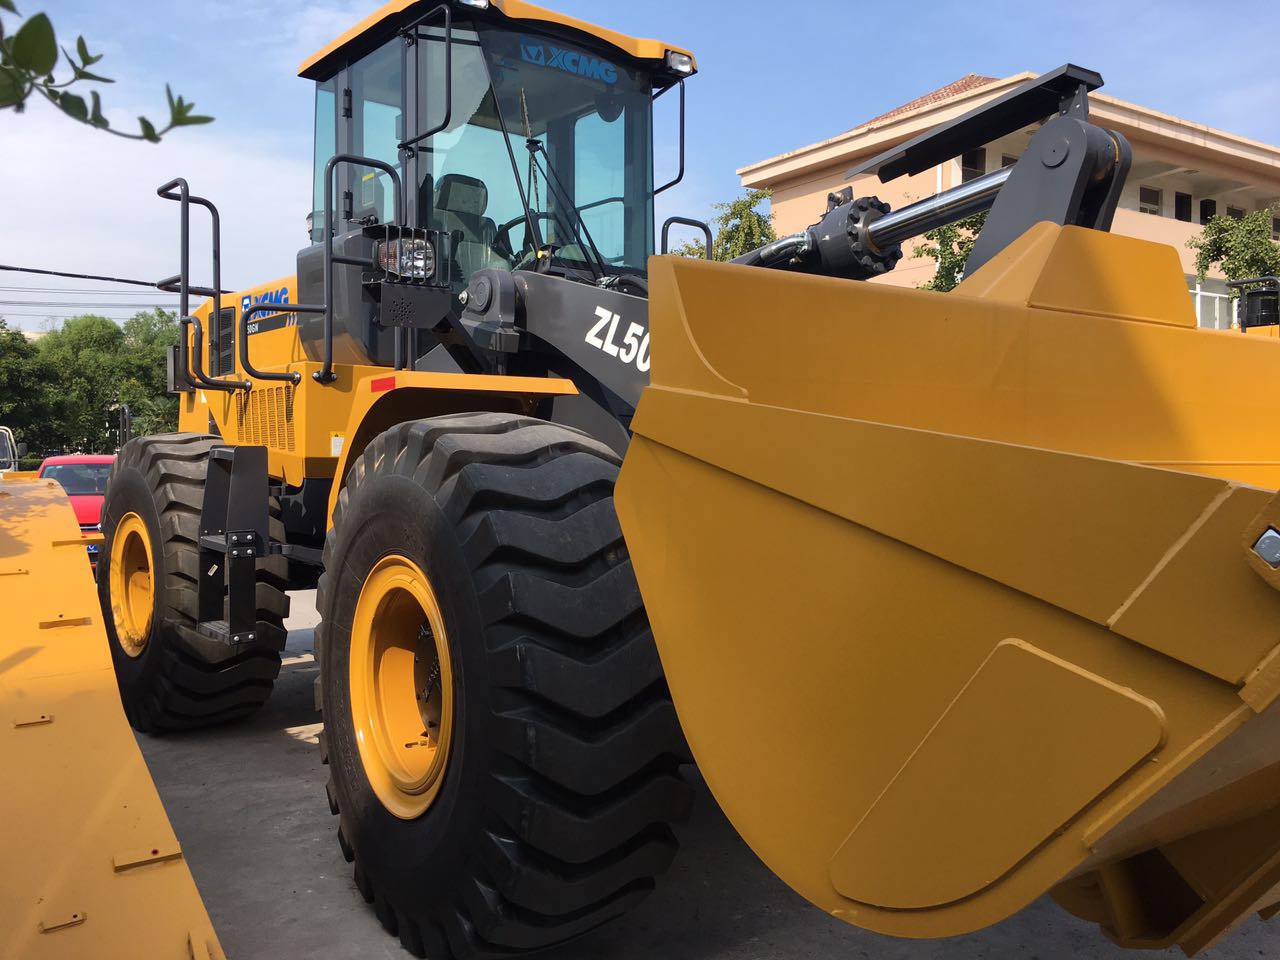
0,104,311,329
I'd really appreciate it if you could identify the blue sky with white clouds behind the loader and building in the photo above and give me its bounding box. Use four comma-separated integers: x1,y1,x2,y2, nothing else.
0,0,1280,328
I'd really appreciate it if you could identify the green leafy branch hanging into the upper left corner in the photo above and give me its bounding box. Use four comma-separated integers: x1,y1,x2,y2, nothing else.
0,0,214,143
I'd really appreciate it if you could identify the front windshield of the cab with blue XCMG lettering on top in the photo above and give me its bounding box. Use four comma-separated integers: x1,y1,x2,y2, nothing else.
419,24,653,284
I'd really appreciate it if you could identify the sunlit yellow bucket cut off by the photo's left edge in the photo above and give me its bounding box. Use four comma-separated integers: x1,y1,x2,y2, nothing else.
0,474,225,960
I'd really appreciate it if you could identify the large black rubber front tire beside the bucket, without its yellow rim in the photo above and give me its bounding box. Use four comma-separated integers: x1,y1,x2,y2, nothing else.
316,413,691,960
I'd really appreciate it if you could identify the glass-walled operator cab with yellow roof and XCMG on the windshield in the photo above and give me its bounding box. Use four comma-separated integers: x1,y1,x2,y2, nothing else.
298,0,694,373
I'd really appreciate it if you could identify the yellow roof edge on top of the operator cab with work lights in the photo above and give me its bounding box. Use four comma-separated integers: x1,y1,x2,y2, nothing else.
298,0,696,79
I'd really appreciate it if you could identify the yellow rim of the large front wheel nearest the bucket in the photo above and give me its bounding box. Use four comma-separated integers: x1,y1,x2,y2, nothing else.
349,554,453,820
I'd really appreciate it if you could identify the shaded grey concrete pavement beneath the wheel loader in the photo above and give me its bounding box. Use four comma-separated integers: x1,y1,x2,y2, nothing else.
140,593,1280,960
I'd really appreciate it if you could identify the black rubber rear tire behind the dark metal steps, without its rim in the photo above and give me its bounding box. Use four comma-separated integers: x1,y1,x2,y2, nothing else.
97,434,289,733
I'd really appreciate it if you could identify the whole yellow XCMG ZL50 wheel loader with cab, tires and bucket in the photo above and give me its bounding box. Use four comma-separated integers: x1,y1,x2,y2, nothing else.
7,0,1280,959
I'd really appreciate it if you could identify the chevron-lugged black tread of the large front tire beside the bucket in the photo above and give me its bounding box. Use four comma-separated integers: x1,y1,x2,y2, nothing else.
316,413,692,960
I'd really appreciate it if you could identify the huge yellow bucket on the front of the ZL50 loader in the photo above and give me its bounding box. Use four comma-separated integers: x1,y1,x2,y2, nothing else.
617,223,1280,954
